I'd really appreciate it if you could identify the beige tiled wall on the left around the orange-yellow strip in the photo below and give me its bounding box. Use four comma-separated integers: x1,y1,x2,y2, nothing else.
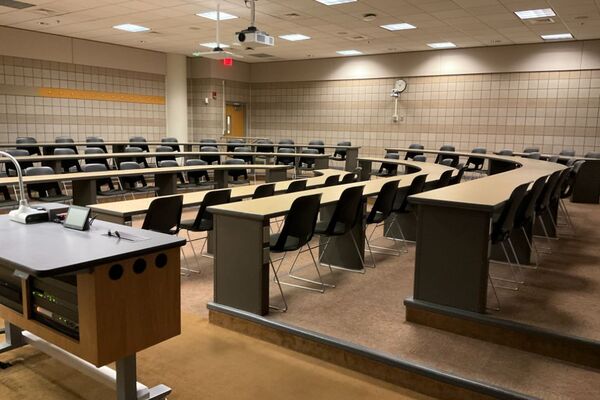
0,56,166,142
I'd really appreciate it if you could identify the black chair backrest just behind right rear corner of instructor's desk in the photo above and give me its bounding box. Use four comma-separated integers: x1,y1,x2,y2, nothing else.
142,195,183,235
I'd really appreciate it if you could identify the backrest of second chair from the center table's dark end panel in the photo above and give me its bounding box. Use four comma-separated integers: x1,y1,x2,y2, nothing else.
324,186,365,235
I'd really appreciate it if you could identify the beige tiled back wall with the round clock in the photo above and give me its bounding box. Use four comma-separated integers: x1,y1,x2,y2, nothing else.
251,70,600,155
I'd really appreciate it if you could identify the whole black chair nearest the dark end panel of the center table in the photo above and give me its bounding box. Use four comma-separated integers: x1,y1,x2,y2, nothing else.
269,194,321,312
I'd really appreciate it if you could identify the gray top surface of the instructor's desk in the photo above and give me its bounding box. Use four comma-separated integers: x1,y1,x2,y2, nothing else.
0,216,185,277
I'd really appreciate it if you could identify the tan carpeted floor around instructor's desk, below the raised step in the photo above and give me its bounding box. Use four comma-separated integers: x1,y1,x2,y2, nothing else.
0,313,430,400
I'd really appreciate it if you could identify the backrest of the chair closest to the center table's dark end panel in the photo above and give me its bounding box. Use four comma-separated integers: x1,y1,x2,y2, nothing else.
273,193,321,251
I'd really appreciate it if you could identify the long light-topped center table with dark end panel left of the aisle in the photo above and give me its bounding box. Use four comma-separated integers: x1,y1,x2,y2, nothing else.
209,161,451,315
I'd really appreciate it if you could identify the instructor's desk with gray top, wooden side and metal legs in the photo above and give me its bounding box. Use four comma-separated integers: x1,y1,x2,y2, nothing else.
0,216,185,400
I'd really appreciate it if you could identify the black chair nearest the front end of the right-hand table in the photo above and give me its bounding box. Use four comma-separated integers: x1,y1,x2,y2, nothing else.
489,183,529,294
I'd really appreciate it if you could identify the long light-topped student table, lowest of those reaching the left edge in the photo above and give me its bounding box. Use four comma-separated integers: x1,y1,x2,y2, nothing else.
0,164,292,205
